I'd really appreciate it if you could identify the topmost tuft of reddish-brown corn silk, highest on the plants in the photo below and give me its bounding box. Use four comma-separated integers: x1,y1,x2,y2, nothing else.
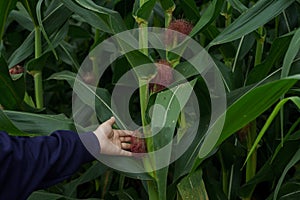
165,19,193,45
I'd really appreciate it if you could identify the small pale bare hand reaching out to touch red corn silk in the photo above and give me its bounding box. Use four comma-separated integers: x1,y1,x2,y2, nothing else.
94,117,133,156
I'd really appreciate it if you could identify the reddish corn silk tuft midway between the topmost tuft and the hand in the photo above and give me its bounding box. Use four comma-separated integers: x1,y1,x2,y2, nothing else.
150,60,174,92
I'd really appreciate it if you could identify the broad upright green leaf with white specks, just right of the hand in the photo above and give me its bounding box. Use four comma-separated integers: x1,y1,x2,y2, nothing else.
147,80,196,199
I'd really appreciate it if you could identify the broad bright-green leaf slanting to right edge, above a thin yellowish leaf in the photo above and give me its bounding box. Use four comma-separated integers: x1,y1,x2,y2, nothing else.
193,75,300,170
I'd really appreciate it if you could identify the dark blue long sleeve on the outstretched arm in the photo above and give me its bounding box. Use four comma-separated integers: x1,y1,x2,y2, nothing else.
0,131,100,200
